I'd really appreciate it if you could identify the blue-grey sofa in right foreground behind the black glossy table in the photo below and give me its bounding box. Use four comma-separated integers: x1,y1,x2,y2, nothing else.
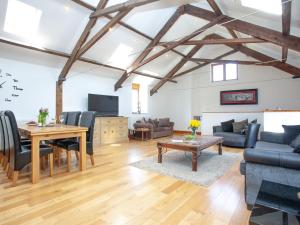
240,132,300,209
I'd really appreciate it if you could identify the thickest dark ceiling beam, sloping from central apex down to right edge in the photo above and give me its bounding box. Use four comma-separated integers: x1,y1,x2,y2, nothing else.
185,5,300,51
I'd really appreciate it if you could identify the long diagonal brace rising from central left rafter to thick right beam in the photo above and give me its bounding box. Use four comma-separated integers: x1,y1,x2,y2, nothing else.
125,16,223,73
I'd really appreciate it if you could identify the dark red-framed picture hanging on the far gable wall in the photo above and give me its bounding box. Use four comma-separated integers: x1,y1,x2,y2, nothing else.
220,89,258,105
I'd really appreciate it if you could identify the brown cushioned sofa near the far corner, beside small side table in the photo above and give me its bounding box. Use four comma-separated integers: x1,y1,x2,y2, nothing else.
133,118,174,138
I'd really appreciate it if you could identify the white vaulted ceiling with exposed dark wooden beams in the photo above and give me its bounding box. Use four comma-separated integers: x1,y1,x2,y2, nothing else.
0,0,300,94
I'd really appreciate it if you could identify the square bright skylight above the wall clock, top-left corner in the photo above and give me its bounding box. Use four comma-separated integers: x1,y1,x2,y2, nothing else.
4,0,42,38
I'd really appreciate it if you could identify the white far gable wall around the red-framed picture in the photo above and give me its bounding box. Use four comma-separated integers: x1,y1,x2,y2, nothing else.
148,51,300,131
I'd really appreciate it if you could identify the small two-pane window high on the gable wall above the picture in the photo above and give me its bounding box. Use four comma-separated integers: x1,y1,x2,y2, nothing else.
211,63,238,82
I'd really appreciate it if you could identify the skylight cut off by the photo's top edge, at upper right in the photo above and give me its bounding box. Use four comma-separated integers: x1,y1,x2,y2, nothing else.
241,0,282,15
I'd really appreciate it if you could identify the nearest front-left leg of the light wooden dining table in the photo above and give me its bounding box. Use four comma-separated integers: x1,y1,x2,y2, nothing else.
31,137,40,184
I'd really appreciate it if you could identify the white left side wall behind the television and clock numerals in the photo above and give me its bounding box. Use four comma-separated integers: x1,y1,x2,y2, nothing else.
0,45,150,127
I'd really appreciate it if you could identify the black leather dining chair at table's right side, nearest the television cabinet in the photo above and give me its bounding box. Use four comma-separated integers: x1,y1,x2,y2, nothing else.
57,111,95,171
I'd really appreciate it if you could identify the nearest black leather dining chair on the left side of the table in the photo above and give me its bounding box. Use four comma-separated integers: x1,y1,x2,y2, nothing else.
4,111,53,186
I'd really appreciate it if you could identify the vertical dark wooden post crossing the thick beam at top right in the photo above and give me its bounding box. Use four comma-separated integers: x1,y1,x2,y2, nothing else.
281,0,292,62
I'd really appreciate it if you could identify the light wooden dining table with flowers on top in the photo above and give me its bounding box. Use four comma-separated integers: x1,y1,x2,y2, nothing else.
19,124,88,184
